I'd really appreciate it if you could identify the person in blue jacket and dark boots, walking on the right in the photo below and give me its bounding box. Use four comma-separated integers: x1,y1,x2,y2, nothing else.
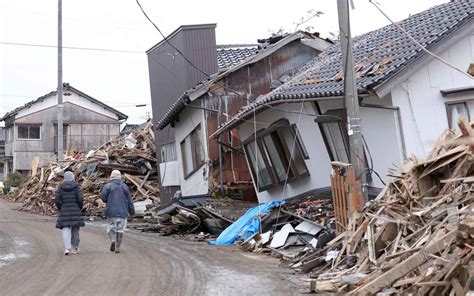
99,170,135,253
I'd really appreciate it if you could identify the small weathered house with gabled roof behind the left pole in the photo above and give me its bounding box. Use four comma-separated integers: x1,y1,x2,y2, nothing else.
0,83,127,178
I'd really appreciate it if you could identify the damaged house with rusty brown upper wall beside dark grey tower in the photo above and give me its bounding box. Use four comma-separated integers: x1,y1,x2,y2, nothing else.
157,31,331,204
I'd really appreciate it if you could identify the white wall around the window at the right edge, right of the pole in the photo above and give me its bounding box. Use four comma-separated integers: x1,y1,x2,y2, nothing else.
391,32,474,156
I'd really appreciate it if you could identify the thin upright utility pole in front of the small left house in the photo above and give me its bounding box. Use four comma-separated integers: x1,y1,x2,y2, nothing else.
58,0,64,161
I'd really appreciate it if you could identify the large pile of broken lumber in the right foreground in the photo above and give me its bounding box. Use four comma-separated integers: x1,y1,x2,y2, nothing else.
300,122,474,295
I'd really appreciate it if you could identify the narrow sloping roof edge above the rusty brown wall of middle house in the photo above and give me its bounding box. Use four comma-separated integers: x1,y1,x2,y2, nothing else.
157,31,322,129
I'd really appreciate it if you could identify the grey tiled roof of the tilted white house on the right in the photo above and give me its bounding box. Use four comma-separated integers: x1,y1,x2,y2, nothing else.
214,0,474,135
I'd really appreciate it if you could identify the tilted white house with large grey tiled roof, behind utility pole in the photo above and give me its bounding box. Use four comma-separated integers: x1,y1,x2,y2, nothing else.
215,1,474,202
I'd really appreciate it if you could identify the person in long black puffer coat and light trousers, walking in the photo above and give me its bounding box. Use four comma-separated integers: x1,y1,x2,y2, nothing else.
54,172,85,255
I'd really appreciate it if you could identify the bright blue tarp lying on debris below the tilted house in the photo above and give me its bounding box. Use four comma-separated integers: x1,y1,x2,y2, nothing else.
209,201,283,245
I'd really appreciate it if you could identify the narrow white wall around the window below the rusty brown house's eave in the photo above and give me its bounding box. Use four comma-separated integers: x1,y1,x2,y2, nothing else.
171,104,209,196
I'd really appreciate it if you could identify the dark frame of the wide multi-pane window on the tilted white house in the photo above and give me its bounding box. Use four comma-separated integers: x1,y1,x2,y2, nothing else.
242,118,310,192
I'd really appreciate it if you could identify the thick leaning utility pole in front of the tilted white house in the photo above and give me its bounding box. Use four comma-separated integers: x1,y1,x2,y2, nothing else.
337,0,368,199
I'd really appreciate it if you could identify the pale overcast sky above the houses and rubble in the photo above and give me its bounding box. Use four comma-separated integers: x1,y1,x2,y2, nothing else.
0,0,447,123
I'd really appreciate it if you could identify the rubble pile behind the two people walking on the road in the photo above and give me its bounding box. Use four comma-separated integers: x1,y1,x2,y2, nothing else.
7,123,160,216
